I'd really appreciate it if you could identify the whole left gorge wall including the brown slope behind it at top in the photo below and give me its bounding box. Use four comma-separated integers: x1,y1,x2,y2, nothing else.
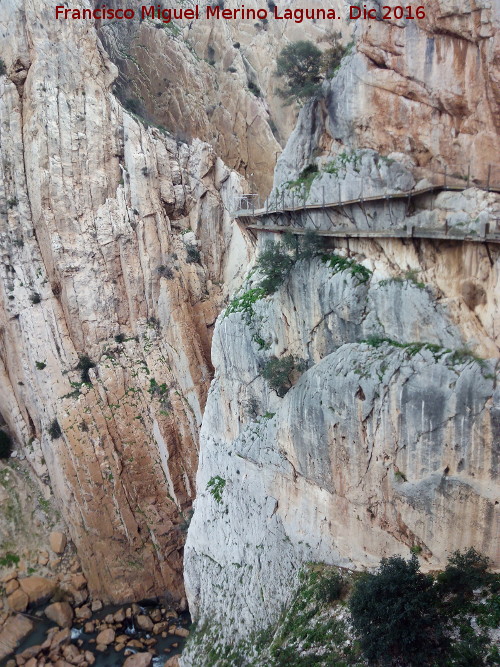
0,0,356,600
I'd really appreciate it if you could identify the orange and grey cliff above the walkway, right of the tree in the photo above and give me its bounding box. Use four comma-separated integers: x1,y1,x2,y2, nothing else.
275,0,500,184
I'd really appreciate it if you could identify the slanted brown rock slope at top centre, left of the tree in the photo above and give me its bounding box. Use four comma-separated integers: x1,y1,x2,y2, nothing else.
94,0,351,194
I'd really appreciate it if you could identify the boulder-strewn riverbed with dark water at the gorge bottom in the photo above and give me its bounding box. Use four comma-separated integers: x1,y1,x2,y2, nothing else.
0,532,190,667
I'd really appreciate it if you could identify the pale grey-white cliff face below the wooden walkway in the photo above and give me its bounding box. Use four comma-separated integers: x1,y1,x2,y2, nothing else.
184,241,500,665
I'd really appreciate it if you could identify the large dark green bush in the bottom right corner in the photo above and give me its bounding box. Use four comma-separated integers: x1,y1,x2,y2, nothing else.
349,548,500,667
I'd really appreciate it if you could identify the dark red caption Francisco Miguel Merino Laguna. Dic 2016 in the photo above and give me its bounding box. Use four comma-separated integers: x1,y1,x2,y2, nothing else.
55,4,425,23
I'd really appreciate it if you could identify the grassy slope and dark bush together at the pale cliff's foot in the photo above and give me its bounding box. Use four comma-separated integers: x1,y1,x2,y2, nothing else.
208,548,500,667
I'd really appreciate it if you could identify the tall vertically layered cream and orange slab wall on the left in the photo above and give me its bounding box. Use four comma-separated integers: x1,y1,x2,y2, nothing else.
0,0,246,600
